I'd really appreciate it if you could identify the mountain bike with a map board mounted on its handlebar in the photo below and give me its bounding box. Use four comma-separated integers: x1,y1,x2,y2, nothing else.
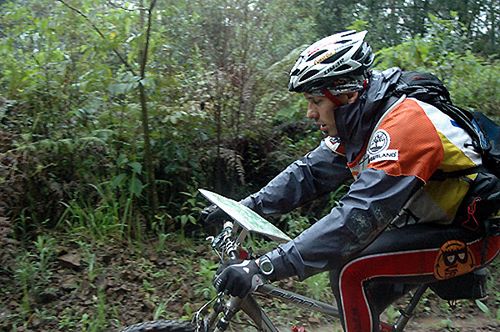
122,189,500,332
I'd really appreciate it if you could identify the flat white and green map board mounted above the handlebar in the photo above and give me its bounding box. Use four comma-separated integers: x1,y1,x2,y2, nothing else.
199,189,291,242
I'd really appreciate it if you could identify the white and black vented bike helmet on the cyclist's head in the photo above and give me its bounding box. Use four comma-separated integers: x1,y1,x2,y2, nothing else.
288,30,374,95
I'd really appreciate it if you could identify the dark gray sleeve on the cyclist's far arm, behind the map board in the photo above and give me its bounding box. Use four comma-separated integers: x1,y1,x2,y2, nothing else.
241,141,352,215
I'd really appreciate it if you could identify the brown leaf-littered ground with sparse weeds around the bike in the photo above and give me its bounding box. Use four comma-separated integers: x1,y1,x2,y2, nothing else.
0,234,500,332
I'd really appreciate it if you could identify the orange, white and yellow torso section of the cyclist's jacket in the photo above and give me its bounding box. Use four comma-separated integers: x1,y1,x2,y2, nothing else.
348,97,481,227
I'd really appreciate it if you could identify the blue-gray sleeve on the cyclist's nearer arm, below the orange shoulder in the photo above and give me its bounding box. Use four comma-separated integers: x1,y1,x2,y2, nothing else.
267,169,424,279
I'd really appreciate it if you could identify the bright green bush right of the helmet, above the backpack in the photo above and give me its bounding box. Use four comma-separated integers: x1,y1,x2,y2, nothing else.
376,16,500,119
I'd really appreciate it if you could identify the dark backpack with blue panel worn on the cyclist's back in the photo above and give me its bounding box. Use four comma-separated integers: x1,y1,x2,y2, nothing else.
392,71,500,179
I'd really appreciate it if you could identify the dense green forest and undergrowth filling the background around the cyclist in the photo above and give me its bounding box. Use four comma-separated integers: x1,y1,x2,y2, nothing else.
0,0,500,331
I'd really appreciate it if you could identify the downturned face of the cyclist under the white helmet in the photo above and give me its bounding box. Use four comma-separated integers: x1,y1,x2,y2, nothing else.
304,93,349,136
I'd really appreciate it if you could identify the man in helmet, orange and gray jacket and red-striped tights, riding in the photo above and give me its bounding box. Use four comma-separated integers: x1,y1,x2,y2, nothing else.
204,31,498,331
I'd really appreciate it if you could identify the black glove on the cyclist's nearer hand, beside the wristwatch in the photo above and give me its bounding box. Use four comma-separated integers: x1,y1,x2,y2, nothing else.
214,260,264,298
